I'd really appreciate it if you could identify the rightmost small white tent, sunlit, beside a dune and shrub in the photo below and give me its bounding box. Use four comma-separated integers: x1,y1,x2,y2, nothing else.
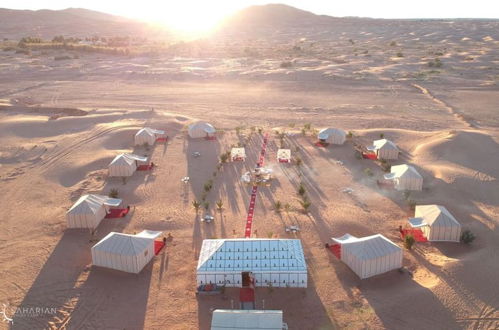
409,204,461,242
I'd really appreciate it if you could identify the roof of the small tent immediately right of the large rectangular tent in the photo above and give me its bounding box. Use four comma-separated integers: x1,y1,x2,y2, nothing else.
335,234,402,260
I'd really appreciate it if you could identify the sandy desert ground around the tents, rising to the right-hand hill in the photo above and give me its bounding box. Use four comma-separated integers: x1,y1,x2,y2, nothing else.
0,5,499,329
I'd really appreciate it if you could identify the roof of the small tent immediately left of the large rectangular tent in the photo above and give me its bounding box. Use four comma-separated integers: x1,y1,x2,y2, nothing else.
93,232,154,256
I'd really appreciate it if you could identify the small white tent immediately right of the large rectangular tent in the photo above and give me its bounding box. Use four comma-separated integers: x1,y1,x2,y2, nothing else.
333,234,402,279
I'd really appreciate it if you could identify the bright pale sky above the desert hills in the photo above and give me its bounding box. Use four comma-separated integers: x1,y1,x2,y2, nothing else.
0,0,499,31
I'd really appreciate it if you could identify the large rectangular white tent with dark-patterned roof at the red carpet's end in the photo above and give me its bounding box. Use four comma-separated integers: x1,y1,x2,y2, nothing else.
197,238,307,288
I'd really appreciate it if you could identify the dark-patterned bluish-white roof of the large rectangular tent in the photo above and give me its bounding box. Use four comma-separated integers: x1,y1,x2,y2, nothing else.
197,238,307,272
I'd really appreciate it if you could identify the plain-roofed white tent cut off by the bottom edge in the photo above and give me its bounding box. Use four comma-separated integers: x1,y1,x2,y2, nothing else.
211,309,288,330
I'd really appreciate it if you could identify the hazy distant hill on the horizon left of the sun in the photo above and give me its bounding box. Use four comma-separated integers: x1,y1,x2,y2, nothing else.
0,8,163,39
